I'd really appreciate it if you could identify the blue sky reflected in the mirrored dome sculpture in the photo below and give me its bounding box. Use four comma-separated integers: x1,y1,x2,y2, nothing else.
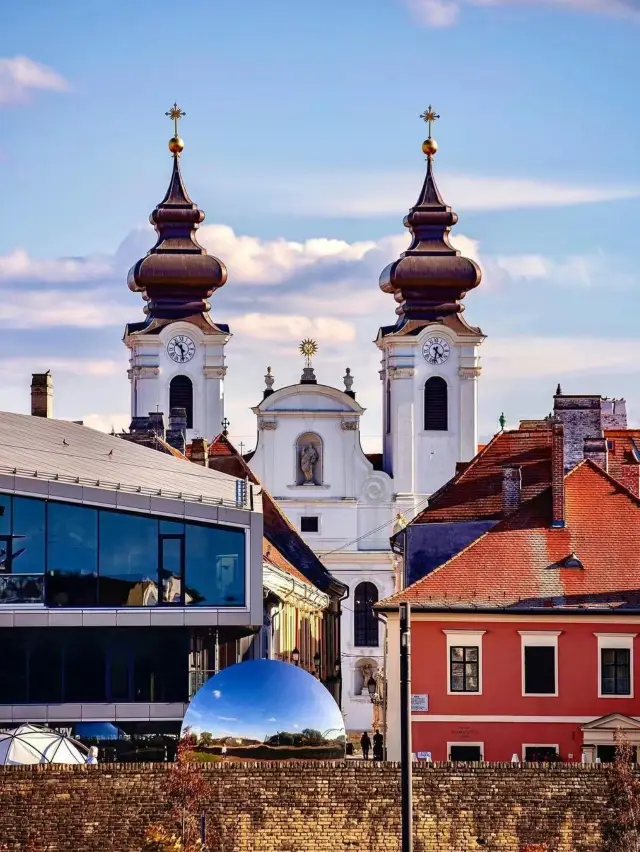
182,660,344,742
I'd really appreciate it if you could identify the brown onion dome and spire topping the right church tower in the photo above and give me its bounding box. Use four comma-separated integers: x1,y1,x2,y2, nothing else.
380,107,482,324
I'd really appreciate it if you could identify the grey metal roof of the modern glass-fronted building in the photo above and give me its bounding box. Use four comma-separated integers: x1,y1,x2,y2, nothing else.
0,411,245,507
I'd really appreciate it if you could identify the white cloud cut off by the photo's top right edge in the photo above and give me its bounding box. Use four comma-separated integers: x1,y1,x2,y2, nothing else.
402,0,640,27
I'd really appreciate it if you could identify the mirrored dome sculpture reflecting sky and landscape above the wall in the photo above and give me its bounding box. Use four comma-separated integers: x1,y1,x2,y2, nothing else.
181,660,346,761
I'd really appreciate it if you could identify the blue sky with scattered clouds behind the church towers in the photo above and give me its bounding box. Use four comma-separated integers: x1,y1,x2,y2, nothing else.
0,0,640,451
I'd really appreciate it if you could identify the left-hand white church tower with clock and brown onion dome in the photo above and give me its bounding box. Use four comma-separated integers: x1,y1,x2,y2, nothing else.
124,104,230,440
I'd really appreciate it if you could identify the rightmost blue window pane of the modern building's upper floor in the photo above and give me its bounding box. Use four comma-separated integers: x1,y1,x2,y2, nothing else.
185,524,244,606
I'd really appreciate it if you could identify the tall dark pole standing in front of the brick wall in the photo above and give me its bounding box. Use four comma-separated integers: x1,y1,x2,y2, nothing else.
400,603,413,852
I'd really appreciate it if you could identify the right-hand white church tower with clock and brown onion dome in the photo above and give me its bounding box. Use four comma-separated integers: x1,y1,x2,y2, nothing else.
376,106,484,518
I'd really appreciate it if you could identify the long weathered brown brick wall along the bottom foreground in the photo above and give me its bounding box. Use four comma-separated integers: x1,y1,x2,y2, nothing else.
0,762,610,852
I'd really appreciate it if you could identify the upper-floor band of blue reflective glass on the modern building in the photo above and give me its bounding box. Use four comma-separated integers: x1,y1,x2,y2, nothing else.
0,494,245,607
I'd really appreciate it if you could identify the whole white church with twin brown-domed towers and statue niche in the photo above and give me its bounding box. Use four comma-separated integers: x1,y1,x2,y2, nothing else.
124,110,484,731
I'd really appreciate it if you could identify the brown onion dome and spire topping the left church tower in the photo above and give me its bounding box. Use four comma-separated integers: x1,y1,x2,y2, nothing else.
127,104,227,319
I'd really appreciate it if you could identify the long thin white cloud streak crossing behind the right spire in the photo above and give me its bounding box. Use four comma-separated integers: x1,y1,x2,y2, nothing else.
228,171,640,216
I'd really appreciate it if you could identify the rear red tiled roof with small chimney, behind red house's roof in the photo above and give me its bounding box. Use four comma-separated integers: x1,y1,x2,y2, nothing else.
411,428,551,524
